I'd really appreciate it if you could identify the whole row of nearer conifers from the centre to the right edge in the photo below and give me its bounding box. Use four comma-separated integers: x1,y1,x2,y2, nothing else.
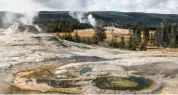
61,23,178,51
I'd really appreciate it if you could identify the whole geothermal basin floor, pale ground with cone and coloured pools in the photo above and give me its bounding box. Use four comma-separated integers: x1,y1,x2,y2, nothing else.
0,24,178,94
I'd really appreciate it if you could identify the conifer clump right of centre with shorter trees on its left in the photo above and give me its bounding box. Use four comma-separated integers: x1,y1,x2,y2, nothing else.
110,25,150,51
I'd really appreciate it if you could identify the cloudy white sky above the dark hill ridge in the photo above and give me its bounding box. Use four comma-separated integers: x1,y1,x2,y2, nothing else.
0,0,178,14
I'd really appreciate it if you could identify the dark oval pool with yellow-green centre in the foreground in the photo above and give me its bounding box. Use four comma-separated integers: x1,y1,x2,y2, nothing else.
94,76,153,91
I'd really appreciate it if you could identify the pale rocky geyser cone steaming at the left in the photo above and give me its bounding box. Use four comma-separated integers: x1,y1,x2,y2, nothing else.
4,23,39,35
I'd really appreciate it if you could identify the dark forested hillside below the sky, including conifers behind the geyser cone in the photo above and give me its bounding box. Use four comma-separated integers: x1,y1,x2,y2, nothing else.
0,11,178,32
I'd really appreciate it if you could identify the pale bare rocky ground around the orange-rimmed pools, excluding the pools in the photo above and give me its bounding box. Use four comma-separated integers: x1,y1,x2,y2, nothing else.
0,24,178,94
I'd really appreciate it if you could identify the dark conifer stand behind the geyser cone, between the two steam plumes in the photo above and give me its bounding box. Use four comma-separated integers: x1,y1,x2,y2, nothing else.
34,19,93,33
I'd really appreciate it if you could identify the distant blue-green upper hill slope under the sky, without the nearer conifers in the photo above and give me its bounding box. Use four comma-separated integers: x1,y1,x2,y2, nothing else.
38,11,178,26
